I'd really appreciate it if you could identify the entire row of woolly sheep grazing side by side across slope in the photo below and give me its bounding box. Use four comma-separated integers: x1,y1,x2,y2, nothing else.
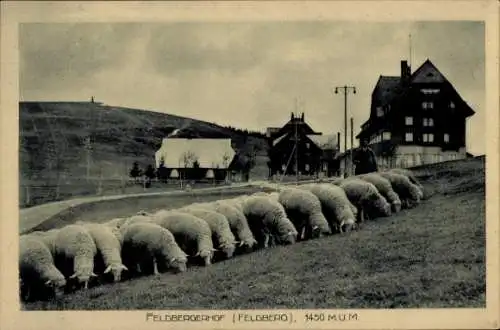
19,169,423,300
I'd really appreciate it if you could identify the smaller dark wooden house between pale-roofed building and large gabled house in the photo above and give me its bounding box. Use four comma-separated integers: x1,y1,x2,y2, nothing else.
267,113,339,177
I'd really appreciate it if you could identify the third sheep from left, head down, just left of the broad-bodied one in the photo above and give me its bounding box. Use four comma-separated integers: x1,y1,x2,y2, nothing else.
76,223,128,282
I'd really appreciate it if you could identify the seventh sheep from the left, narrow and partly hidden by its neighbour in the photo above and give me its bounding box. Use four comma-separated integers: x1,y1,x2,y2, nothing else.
203,200,257,249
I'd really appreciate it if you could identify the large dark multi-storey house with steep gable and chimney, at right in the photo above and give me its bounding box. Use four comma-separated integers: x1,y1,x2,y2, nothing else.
356,59,475,168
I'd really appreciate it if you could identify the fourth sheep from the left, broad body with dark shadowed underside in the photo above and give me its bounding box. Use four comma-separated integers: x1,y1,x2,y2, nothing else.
120,221,187,275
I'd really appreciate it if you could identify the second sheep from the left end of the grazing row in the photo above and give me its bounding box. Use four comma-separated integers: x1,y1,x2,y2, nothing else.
55,225,97,289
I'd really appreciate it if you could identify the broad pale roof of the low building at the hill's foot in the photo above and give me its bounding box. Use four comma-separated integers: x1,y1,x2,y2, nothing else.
155,138,236,169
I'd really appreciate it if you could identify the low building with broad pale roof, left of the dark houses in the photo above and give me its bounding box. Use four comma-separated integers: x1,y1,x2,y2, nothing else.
155,138,236,180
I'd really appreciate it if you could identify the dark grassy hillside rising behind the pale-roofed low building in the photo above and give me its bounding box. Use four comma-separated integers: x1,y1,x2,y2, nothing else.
19,102,267,206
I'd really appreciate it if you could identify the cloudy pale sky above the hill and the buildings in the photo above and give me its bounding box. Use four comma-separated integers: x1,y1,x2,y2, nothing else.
19,21,486,154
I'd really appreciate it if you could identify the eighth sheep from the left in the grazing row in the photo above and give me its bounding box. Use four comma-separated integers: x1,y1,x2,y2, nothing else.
243,196,298,248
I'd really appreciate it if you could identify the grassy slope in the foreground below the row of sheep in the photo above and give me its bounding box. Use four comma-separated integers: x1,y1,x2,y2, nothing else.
24,158,486,310
